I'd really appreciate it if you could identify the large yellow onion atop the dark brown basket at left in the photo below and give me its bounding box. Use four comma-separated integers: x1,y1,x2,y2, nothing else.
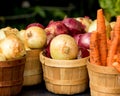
0,34,26,60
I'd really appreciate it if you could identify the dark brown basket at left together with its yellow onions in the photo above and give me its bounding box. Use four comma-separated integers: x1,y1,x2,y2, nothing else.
0,27,26,96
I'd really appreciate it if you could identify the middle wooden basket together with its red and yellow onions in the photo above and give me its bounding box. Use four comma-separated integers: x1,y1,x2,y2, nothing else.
39,18,90,95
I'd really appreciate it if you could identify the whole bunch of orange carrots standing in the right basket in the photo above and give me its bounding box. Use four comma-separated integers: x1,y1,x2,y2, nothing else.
90,9,120,72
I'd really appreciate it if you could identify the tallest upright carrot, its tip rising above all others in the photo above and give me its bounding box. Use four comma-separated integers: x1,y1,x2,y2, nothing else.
97,9,107,66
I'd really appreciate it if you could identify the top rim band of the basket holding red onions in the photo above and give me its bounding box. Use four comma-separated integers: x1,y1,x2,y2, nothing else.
39,51,89,68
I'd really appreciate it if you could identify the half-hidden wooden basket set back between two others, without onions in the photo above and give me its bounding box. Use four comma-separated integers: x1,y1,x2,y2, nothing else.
23,49,42,86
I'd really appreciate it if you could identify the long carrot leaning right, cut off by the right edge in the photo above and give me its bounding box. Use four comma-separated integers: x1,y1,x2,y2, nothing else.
107,16,120,66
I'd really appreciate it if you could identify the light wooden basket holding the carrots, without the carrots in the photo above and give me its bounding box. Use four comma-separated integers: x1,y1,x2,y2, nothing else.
87,63,120,96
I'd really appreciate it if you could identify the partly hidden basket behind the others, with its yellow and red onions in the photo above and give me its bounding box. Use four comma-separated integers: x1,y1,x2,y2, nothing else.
18,23,46,86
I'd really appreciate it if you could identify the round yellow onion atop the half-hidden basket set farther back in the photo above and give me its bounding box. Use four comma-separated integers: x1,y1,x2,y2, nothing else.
25,26,47,48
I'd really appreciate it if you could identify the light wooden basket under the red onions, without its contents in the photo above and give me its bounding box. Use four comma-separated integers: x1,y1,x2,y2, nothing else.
40,52,88,95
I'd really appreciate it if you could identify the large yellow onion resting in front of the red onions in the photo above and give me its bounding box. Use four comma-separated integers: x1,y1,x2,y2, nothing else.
50,34,78,60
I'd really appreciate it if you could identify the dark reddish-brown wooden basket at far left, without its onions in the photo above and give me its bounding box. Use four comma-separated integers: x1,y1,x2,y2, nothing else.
0,56,26,96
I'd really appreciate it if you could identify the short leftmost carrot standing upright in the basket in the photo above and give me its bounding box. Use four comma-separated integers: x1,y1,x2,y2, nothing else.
90,31,101,65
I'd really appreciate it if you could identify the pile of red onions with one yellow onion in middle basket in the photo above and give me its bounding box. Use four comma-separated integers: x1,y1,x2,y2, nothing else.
45,17,91,59
